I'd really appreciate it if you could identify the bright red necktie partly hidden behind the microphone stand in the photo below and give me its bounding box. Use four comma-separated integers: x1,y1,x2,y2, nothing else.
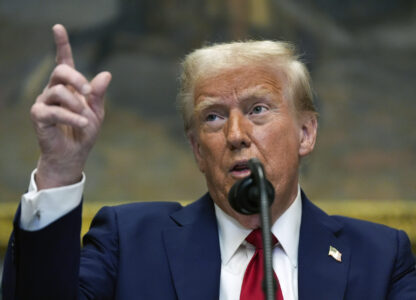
240,229,283,300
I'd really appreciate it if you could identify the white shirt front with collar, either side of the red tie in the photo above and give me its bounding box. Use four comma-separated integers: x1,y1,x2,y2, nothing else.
215,187,302,300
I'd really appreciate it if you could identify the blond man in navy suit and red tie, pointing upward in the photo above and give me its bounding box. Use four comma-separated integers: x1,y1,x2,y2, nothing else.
3,25,416,300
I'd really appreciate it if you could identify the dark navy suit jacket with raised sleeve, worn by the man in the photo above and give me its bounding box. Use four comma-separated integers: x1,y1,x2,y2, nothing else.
3,194,416,300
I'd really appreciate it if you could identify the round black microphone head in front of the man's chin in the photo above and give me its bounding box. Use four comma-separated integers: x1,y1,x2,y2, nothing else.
228,158,274,215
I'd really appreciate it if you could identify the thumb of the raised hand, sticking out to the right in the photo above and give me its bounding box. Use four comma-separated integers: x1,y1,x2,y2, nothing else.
88,72,111,118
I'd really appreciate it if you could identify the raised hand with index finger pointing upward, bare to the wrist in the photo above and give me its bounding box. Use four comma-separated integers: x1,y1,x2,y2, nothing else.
31,25,111,190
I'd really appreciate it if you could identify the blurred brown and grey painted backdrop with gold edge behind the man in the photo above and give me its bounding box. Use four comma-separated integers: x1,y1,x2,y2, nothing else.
0,0,416,288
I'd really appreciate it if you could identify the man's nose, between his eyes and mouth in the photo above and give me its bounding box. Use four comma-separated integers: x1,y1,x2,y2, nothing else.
224,111,251,150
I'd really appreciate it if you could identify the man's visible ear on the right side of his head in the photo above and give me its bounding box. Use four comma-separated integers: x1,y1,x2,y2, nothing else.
299,112,318,157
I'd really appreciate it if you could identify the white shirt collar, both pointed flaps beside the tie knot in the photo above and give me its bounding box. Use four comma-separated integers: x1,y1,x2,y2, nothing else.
215,186,302,268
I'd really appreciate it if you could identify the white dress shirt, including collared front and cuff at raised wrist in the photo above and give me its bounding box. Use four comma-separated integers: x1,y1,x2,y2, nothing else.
20,170,302,300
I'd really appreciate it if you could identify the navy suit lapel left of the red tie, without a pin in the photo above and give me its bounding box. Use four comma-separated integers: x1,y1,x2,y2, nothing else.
163,194,221,300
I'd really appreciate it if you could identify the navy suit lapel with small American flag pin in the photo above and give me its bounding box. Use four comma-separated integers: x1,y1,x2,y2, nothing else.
298,193,350,300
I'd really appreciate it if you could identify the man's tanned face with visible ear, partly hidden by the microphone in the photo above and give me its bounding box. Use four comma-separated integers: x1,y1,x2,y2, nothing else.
189,67,316,228
